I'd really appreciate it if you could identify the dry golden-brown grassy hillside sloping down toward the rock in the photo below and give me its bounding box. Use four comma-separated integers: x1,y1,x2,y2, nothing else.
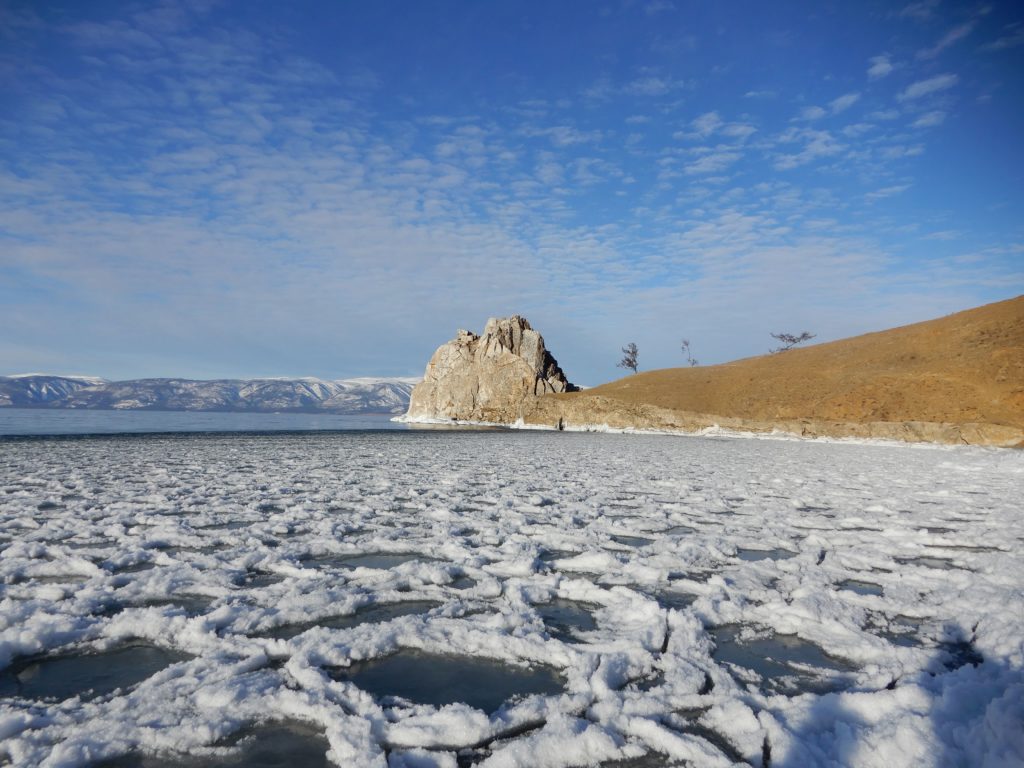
573,296,1024,428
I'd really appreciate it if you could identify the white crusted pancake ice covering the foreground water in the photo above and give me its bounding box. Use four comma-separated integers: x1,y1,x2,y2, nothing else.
0,432,1024,768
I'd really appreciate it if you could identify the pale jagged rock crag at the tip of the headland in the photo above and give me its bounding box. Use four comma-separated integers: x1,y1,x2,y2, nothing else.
406,314,577,424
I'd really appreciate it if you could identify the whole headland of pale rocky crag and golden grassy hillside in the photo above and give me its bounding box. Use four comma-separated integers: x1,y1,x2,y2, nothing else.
403,297,1024,447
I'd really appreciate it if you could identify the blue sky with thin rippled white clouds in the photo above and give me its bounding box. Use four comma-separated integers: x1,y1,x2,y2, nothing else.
0,0,1024,384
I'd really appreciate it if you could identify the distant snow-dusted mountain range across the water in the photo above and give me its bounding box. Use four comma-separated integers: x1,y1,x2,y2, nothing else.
0,374,419,414
